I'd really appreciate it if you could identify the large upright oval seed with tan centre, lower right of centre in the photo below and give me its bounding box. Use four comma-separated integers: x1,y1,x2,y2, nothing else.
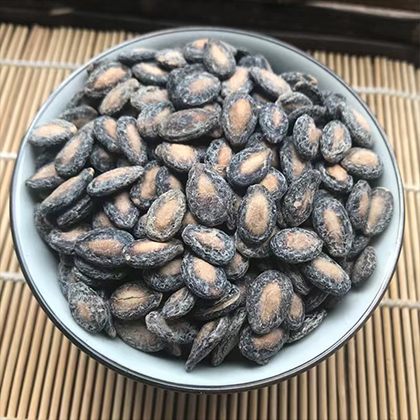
246,270,293,334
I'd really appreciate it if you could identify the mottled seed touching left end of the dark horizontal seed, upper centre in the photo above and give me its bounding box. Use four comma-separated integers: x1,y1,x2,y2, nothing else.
137,101,174,140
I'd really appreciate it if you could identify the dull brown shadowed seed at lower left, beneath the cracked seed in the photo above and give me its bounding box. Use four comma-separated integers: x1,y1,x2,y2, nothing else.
115,319,166,353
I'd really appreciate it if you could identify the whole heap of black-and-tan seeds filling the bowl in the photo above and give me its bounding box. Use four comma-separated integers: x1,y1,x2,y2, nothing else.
27,39,393,371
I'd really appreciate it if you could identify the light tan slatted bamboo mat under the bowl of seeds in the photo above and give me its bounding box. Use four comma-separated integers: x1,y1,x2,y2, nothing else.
0,24,420,420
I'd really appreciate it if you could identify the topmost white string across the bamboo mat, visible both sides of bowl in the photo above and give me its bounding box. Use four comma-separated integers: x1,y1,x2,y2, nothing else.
0,58,420,100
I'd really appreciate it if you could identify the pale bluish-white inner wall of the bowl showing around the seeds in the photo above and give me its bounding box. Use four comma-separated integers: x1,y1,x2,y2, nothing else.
12,28,403,391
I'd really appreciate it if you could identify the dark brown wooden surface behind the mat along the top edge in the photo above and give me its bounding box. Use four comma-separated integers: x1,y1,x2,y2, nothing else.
0,0,420,65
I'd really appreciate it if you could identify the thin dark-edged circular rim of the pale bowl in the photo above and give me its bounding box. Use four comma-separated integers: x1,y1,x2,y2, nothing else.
10,26,405,394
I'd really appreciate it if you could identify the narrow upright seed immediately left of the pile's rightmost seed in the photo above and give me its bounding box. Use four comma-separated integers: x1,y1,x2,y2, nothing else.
346,179,372,229
